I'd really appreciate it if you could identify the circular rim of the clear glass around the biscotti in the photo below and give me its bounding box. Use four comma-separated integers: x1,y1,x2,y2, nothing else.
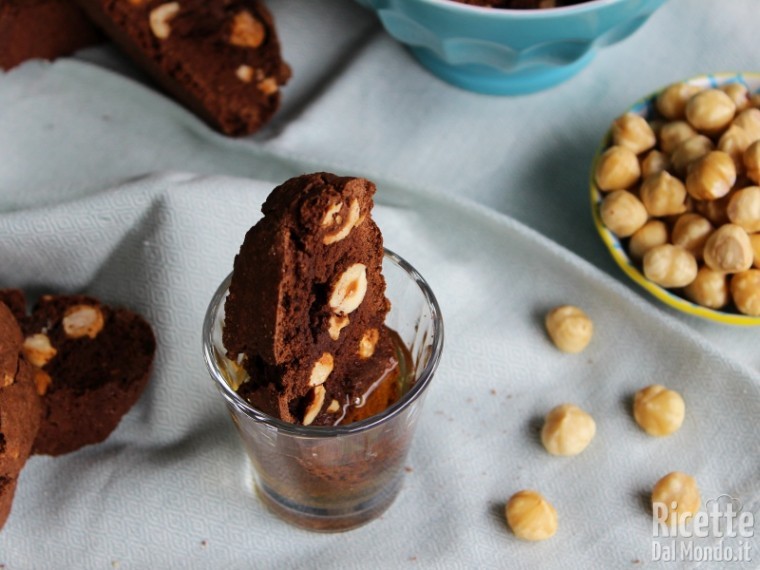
203,248,443,439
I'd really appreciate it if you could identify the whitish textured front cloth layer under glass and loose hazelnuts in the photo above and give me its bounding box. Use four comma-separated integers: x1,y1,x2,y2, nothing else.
0,174,760,569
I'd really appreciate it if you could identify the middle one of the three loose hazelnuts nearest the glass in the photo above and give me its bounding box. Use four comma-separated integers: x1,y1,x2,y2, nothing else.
541,404,596,456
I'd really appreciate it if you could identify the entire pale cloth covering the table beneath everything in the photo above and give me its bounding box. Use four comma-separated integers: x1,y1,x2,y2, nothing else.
0,0,760,569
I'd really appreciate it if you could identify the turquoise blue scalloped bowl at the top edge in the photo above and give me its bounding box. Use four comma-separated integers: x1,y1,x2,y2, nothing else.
357,0,665,95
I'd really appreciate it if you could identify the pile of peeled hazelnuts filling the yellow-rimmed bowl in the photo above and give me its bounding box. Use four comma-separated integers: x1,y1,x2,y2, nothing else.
594,83,760,316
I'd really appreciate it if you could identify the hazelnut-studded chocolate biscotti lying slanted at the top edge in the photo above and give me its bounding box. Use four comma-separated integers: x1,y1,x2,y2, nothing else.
76,0,290,136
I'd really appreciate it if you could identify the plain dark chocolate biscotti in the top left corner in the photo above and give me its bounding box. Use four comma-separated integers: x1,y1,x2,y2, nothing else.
0,0,102,69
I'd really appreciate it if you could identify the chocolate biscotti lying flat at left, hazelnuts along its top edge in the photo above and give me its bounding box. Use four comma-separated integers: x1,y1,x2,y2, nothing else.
22,295,156,455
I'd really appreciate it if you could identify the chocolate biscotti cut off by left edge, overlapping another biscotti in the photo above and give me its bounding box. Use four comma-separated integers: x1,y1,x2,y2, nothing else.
0,302,42,528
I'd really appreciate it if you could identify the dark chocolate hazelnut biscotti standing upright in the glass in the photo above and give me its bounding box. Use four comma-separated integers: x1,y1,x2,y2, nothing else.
223,173,394,425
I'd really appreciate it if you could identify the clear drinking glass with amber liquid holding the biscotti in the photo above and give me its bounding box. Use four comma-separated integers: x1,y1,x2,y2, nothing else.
203,250,443,532
